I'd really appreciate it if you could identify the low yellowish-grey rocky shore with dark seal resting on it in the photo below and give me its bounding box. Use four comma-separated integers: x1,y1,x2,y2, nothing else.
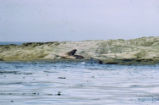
0,37,159,65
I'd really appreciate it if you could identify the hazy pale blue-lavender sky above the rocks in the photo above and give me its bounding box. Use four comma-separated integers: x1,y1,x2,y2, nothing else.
0,0,159,42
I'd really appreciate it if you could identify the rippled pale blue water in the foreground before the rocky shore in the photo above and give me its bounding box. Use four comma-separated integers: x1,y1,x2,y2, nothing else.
0,62,159,105
